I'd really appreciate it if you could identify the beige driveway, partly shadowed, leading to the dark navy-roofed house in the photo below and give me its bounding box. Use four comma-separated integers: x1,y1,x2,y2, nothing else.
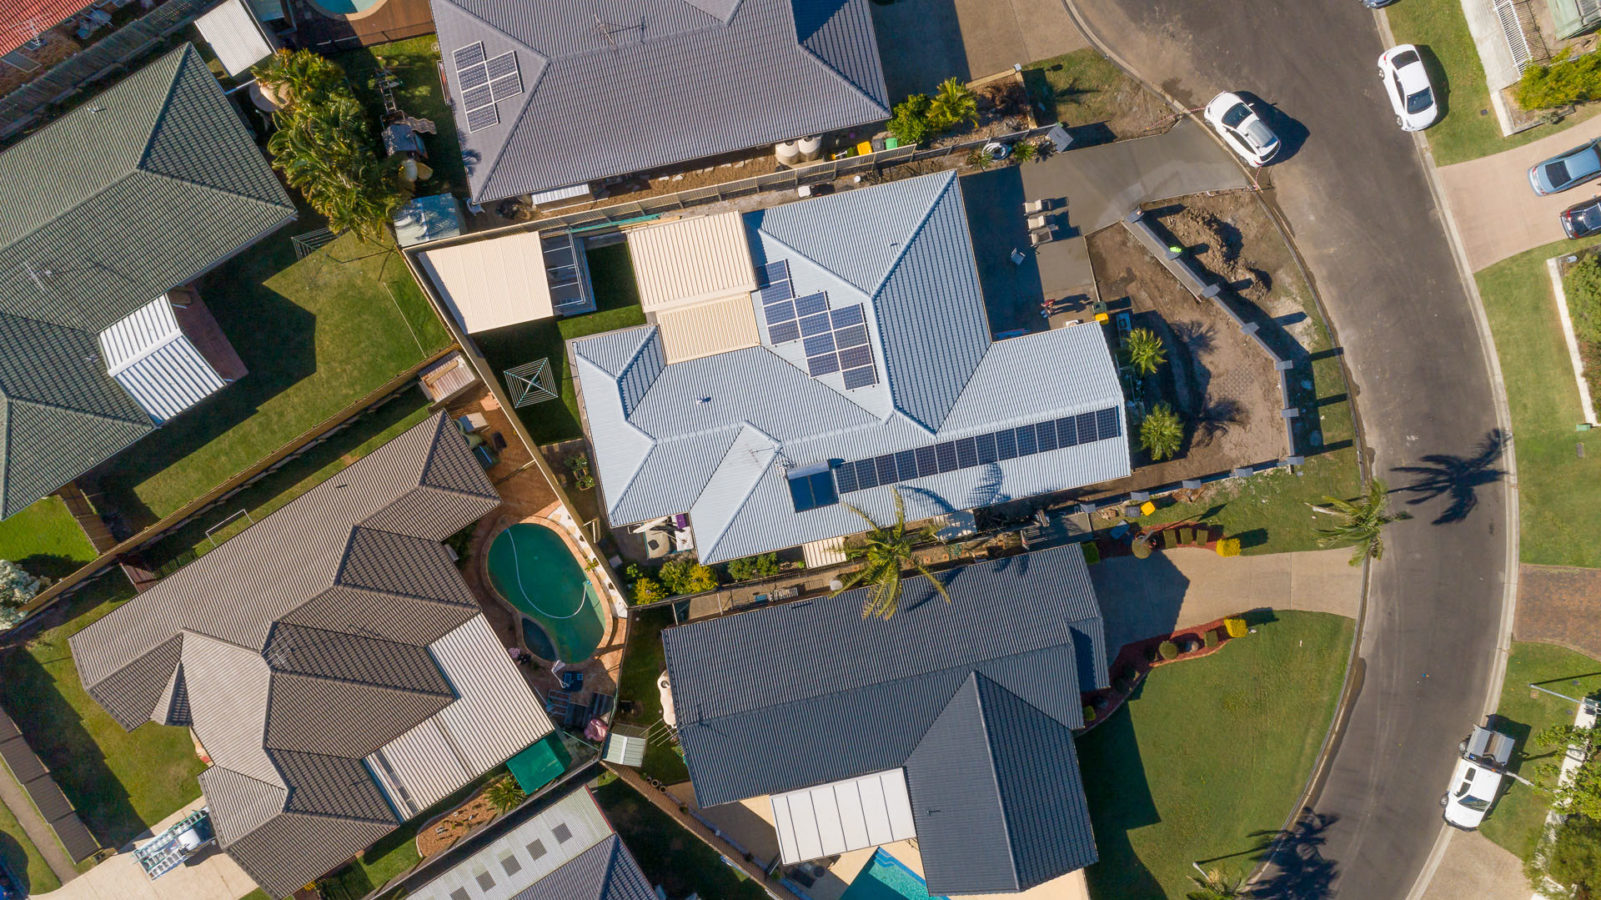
1090,549,1362,653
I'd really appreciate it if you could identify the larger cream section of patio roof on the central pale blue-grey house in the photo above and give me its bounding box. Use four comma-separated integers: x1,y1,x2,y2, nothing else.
628,211,756,312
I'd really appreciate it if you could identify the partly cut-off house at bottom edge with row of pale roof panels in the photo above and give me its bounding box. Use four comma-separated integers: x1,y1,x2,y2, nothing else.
405,786,656,900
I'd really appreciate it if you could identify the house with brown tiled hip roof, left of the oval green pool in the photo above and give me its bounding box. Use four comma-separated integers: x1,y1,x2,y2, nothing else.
70,413,552,897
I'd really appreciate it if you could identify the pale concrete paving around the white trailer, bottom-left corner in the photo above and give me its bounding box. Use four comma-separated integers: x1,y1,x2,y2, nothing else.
35,798,256,900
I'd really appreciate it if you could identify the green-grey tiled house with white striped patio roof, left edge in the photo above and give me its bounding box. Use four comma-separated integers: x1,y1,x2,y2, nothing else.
0,45,295,516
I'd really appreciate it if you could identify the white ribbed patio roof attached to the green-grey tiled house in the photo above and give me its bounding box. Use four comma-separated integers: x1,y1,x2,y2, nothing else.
99,295,226,424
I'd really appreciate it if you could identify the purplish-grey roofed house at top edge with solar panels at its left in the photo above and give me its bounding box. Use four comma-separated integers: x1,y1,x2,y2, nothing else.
431,0,890,203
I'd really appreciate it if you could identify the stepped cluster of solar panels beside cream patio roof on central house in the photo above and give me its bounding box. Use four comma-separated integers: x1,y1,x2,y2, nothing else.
757,259,879,391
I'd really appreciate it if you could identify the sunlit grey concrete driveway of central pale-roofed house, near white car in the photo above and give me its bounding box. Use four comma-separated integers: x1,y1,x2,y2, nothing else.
1017,120,1250,234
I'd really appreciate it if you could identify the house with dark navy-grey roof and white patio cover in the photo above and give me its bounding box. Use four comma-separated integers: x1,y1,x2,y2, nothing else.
661,544,1108,895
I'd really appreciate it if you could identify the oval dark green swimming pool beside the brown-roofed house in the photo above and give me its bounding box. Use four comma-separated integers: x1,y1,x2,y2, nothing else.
487,522,607,663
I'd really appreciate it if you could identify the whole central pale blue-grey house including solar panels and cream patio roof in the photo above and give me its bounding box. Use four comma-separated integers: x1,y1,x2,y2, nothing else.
568,173,1130,564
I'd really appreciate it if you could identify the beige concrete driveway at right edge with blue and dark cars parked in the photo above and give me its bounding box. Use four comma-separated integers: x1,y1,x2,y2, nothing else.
1439,119,1601,272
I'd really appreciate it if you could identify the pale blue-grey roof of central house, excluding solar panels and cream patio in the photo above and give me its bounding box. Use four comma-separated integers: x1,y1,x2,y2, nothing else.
572,173,1130,562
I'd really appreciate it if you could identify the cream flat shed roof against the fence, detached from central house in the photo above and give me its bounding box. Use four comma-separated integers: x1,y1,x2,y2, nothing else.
418,231,556,333
